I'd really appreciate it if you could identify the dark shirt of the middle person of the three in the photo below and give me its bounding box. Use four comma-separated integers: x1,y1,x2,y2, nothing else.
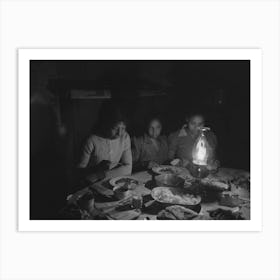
132,134,168,164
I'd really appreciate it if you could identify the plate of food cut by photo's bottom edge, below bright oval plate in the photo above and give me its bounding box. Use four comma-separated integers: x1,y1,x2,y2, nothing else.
157,205,198,220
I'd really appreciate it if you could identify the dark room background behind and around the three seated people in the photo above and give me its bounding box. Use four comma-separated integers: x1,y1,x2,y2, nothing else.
30,60,250,218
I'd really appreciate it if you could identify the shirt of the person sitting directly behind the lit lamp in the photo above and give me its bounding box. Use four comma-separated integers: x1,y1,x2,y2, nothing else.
168,126,217,162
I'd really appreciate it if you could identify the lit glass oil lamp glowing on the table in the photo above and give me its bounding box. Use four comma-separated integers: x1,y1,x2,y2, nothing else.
190,127,210,179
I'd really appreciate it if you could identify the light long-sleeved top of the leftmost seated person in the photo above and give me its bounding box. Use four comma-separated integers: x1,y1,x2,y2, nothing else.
78,133,132,177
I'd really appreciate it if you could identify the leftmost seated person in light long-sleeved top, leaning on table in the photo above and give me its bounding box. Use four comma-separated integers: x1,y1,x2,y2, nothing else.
78,105,132,182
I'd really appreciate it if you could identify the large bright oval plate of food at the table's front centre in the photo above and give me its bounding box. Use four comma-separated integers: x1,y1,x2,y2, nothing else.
151,187,201,206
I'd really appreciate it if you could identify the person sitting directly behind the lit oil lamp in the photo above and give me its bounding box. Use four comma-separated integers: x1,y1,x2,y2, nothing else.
168,113,218,170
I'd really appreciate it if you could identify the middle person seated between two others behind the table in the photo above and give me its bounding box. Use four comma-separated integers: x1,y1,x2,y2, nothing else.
132,117,168,170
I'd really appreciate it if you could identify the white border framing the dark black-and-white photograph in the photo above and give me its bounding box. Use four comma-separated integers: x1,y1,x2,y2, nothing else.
18,49,262,231
